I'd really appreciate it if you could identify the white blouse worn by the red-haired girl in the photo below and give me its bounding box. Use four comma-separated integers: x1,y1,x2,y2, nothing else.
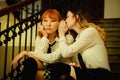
31,35,76,64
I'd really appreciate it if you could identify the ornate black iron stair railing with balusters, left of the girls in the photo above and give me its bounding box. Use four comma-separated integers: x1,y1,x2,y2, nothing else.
0,0,39,80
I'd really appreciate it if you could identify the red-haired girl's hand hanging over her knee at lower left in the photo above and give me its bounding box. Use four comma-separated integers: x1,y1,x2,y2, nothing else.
11,51,28,67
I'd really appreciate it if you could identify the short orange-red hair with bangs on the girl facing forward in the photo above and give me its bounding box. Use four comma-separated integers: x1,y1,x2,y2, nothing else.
41,9,61,21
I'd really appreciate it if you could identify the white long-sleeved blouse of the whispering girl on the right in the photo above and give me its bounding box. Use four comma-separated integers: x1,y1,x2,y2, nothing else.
59,28,110,70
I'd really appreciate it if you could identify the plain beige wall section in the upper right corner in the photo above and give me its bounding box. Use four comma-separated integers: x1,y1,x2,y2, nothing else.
104,0,120,18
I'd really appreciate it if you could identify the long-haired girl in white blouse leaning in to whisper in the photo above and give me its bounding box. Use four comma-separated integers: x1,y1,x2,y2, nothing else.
49,9,112,80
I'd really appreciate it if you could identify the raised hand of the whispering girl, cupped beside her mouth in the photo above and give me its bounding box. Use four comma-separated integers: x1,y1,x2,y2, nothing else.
58,20,68,36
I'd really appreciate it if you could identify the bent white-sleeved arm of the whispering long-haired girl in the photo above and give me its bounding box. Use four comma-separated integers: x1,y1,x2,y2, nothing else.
59,28,98,57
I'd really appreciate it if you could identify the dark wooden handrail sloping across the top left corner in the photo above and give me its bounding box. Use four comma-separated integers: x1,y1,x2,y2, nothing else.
0,0,38,17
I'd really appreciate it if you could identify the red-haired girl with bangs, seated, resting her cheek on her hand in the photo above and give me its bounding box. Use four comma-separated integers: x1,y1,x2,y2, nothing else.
12,9,75,80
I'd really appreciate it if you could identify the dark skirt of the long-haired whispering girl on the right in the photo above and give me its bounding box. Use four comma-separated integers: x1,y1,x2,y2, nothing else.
74,67,113,80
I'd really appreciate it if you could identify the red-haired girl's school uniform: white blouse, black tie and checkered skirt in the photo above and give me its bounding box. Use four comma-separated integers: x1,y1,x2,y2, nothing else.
31,34,77,80
